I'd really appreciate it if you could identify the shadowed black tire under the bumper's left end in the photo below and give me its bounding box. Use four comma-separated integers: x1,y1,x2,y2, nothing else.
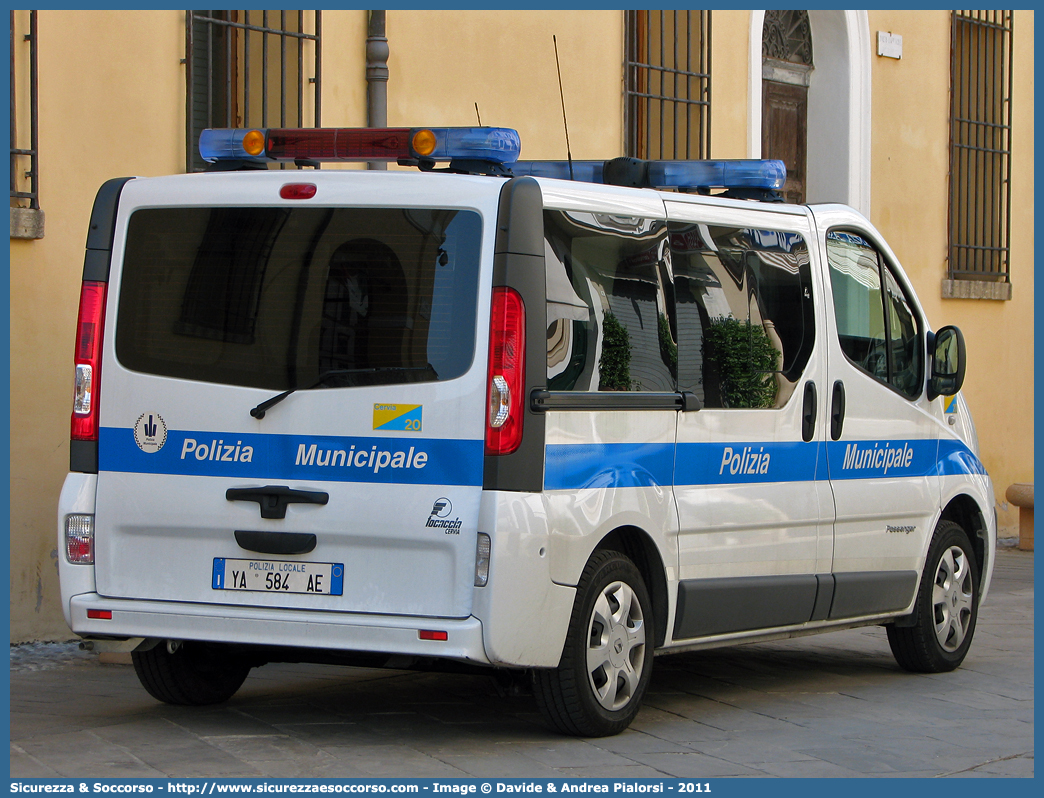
131,640,251,706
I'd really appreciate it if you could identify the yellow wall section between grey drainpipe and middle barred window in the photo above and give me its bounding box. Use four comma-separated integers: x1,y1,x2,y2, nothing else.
387,10,623,160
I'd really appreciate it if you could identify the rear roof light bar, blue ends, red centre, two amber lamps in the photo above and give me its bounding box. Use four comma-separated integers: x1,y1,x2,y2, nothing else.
199,127,522,164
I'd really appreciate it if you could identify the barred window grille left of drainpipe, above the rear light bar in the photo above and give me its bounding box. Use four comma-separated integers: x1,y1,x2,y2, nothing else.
185,10,323,171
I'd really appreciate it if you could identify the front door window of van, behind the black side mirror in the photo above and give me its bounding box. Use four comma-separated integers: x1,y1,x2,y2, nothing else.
827,231,923,399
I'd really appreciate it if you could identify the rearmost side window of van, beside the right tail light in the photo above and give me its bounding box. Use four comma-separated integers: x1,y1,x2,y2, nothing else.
544,211,678,392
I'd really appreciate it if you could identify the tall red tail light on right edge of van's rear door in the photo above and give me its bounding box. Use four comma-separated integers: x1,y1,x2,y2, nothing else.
485,287,525,454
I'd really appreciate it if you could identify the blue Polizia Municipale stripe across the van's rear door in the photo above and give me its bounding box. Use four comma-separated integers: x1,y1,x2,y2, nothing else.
98,427,483,486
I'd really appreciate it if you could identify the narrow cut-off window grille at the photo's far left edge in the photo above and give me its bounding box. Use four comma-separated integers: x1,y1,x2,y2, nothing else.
9,10,40,210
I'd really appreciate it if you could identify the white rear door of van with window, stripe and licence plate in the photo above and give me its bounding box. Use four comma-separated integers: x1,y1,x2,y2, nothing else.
96,172,498,617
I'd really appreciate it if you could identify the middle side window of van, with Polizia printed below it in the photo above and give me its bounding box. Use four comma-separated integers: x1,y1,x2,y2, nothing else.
669,222,815,408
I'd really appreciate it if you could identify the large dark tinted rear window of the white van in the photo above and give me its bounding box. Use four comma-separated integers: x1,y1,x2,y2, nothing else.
116,208,481,391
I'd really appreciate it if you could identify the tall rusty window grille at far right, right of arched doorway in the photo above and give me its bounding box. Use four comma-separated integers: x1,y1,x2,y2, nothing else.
948,10,1013,282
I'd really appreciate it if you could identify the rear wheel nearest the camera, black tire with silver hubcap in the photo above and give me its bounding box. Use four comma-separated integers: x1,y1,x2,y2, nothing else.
533,550,656,737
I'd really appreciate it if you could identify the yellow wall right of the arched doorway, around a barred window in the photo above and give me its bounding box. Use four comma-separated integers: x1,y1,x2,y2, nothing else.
870,10,1034,537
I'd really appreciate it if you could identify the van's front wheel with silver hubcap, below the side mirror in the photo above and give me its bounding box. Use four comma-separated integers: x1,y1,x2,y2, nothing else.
887,521,979,674
